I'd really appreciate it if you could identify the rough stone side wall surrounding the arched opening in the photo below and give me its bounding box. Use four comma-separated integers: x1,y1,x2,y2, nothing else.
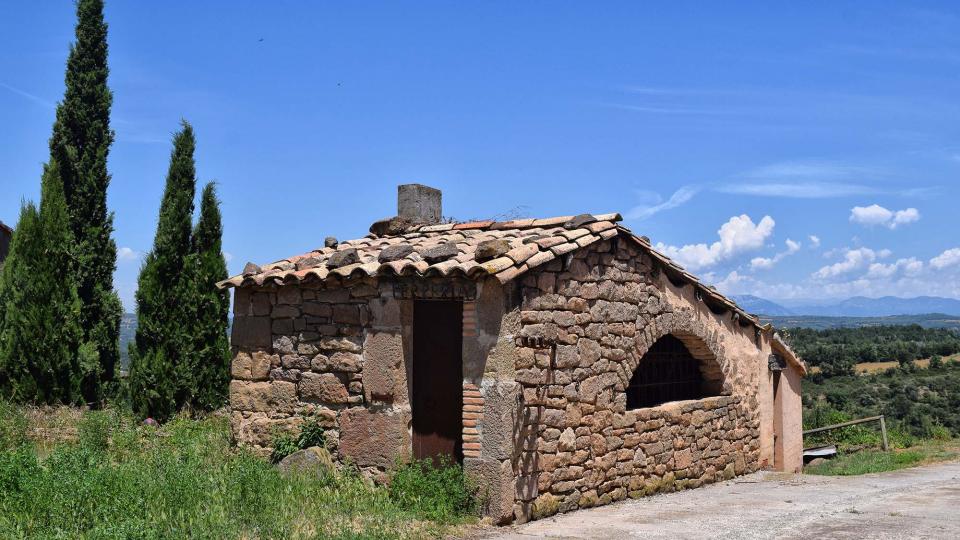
514,239,764,520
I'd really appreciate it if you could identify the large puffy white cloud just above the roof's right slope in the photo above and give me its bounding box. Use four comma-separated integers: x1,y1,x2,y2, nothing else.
657,214,776,270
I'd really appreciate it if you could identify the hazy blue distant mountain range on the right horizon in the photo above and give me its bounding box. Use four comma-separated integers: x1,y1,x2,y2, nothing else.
732,295,960,317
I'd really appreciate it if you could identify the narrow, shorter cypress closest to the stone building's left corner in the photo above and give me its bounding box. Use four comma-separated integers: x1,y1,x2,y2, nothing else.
192,182,230,410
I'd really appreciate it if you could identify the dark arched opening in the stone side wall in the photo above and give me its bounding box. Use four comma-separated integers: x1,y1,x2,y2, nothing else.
627,334,723,409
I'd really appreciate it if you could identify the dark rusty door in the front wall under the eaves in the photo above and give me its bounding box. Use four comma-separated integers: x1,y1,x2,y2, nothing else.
411,300,463,463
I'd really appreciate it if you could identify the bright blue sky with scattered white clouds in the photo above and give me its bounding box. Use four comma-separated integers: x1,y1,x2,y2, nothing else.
0,1,960,310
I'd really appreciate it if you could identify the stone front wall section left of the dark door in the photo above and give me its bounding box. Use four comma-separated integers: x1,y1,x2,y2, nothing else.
230,280,410,470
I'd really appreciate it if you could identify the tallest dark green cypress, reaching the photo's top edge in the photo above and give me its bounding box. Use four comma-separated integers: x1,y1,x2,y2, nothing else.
50,0,122,402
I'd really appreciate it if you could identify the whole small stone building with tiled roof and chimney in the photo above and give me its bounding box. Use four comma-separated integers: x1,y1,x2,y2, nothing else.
221,185,806,523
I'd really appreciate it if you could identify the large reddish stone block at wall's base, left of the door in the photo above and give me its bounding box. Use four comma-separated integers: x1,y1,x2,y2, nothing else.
340,407,410,469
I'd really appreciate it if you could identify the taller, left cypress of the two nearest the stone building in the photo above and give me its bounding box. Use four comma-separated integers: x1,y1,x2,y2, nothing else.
130,122,196,420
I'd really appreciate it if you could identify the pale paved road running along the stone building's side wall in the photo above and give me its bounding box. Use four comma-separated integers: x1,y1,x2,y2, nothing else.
481,463,960,540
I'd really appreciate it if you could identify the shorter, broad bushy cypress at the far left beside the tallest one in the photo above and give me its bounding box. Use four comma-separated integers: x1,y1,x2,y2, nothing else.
0,161,87,403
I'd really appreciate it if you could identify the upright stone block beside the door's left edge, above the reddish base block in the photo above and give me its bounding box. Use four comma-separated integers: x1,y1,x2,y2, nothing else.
362,331,407,402
